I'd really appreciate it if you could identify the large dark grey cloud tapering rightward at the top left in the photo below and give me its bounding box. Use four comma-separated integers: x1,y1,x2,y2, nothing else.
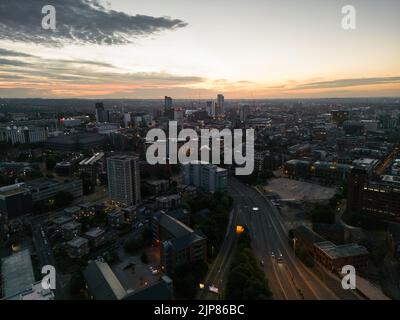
0,0,187,46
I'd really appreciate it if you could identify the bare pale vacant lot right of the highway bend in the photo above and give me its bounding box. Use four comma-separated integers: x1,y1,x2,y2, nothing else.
265,178,335,201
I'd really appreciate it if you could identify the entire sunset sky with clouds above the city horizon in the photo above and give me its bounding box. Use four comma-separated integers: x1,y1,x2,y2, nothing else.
0,0,400,99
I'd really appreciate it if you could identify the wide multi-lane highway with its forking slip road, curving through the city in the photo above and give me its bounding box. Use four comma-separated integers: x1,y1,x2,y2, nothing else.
199,177,360,300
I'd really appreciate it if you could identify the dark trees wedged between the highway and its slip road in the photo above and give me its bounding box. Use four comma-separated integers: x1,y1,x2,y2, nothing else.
225,233,272,300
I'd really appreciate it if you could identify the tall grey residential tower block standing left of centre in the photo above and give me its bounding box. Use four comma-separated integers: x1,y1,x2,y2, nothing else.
107,155,141,206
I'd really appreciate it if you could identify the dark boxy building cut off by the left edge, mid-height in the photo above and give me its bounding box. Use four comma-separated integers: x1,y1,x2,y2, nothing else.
0,183,32,221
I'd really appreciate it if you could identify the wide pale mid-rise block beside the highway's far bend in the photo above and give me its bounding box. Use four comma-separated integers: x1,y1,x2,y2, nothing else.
183,161,228,192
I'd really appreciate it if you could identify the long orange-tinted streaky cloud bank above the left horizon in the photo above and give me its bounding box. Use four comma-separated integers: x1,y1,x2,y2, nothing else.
0,52,206,97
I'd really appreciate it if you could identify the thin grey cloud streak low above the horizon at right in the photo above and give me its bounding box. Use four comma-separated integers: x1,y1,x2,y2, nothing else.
292,77,400,90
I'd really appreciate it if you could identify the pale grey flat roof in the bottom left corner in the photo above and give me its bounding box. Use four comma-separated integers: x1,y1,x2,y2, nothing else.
1,249,35,297
